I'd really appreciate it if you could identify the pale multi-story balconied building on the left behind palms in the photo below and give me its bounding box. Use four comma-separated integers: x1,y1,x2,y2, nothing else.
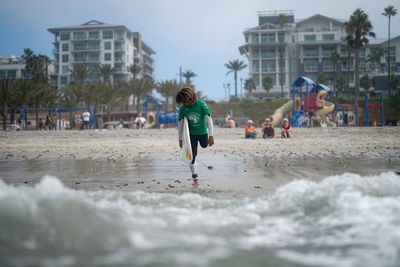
48,20,155,91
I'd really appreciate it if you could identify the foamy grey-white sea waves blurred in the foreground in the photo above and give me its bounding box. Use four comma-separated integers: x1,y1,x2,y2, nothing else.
0,172,400,267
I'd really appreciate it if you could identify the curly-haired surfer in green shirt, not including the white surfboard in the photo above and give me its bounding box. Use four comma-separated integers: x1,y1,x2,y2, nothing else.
176,87,214,186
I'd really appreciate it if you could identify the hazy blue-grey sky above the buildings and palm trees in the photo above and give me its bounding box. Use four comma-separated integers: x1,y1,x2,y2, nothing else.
0,0,400,100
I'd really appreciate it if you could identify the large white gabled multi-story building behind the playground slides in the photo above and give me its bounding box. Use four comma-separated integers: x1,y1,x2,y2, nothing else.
239,11,400,97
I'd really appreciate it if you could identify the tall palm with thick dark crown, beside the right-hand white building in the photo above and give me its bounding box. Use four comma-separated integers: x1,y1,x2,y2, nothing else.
344,8,375,126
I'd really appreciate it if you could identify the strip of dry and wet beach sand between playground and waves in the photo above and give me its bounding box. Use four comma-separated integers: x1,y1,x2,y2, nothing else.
0,127,400,197
